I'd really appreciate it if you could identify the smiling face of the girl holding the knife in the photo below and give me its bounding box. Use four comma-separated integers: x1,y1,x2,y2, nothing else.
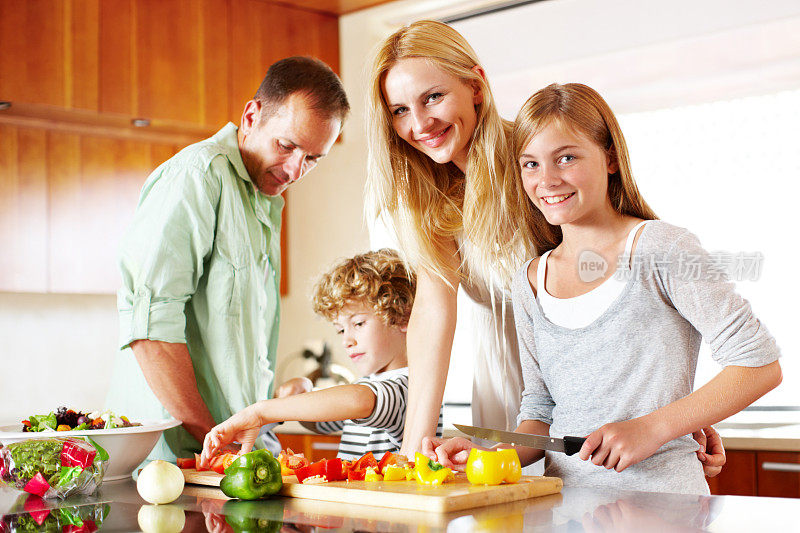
519,122,617,226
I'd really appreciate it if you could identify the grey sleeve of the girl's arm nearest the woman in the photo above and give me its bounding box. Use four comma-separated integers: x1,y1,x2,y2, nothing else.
512,263,555,425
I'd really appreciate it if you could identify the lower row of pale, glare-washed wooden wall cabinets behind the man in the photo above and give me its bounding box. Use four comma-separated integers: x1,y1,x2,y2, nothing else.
0,124,180,294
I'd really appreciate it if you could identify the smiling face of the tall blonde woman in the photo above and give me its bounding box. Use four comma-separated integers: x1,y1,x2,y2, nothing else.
383,57,482,172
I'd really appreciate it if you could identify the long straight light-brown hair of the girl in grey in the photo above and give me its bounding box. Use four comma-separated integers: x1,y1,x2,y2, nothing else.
511,83,658,254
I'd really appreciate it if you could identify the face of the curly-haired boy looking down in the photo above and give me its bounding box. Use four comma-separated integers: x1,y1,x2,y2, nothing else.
333,302,408,376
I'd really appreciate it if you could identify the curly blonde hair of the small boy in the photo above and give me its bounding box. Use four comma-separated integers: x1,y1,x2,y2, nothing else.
313,248,417,326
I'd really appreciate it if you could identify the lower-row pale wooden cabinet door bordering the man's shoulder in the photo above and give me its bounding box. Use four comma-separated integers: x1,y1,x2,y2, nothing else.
47,131,178,294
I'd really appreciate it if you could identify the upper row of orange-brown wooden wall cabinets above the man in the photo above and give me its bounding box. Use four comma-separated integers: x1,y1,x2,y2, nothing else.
0,0,339,130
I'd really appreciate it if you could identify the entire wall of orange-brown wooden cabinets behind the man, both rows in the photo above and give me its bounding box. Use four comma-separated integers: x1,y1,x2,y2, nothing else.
0,0,339,294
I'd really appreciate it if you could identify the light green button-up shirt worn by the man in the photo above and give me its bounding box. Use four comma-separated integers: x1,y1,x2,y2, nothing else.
107,123,284,459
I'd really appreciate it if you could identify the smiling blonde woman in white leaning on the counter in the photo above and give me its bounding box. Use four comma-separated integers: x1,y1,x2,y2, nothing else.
367,21,724,474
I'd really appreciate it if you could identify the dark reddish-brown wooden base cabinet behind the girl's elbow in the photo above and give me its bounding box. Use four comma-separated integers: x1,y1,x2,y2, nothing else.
708,450,800,498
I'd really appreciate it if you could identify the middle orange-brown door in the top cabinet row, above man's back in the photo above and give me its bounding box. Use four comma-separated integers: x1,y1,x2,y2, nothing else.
100,0,229,128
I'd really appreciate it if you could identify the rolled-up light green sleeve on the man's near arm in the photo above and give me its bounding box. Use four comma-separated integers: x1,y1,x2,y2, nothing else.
117,159,220,348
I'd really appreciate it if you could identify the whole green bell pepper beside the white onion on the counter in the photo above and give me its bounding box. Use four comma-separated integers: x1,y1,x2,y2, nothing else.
219,450,283,500
